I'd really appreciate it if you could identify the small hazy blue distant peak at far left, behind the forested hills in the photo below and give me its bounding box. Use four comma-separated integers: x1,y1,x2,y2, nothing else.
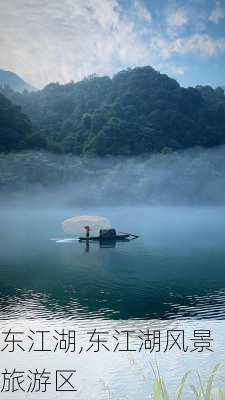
0,69,36,92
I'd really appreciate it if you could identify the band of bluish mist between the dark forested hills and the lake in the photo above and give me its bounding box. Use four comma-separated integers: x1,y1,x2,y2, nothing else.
0,146,225,207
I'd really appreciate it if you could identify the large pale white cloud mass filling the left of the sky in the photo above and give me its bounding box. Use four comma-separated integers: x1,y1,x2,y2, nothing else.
0,0,154,86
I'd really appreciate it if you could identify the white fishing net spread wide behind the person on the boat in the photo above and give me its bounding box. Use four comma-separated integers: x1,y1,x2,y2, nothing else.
62,215,111,236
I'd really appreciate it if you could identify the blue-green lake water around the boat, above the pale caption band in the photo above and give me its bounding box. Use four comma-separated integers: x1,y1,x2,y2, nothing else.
0,208,225,319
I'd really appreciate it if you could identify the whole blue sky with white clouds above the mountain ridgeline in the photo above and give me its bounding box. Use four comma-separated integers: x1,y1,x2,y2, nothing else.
0,0,225,88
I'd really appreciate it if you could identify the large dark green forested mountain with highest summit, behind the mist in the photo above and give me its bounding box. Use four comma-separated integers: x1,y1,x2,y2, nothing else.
3,67,225,156
